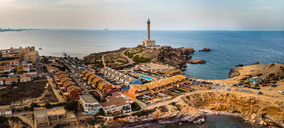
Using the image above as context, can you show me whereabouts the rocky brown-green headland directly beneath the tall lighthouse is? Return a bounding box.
[83,46,195,69]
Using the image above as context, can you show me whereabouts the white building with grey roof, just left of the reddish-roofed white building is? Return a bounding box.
[79,95,102,115]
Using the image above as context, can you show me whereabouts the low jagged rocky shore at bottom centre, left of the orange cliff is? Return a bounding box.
[108,100,205,127]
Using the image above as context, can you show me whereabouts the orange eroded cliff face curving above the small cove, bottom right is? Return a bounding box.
[186,92,284,127]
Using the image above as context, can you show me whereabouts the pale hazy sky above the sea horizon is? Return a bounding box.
[0,0,284,30]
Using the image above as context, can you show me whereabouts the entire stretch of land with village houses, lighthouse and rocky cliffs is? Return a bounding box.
[0,20,284,128]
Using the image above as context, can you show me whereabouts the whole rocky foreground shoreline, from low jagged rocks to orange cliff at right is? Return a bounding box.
[108,92,284,127]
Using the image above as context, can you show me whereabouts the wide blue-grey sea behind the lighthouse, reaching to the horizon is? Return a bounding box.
[0,30,284,80]
